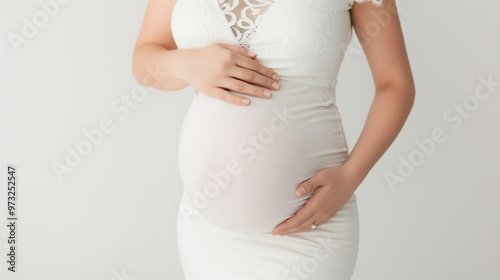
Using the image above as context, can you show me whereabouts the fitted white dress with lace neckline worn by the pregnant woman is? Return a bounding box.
[171,0,382,280]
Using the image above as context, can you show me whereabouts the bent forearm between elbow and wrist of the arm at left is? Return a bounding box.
[132,44,189,91]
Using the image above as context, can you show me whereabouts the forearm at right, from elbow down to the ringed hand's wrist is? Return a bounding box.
[343,86,415,183]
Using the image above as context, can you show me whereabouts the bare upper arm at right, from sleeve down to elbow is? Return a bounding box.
[351,0,414,90]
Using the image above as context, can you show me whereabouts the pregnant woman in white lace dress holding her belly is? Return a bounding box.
[133,0,415,280]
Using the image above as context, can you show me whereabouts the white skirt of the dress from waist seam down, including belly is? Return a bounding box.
[178,79,358,280]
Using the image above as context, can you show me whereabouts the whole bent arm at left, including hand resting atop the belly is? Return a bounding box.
[132,0,279,106]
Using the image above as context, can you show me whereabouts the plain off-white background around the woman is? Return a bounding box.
[0,0,500,280]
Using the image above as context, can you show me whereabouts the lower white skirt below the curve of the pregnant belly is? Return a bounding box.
[177,189,359,280]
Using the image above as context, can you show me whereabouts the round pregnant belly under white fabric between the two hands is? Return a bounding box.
[179,79,348,233]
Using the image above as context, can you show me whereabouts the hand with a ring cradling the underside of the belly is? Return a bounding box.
[272,165,362,235]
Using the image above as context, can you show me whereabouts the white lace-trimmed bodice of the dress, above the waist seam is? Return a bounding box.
[171,0,382,88]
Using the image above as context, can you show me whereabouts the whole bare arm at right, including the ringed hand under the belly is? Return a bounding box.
[273,0,415,235]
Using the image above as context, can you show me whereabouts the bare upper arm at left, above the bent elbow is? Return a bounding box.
[134,0,177,50]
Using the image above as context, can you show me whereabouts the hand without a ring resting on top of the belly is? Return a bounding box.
[179,43,279,105]
